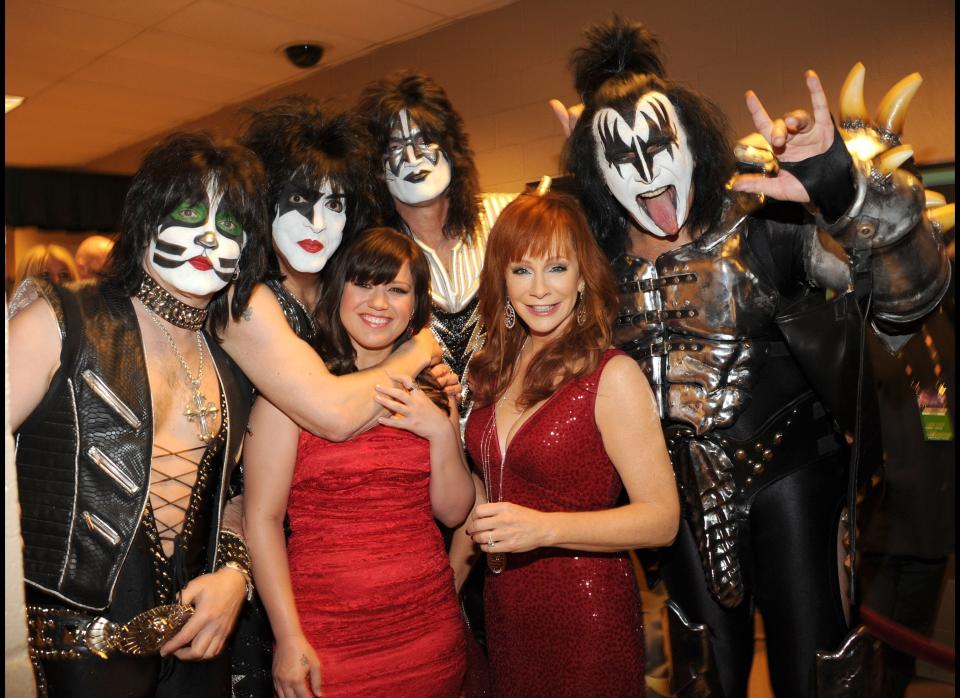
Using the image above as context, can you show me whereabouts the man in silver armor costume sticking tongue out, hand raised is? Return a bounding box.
[559,18,950,698]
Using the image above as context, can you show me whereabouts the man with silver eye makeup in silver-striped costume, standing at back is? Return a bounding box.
[356,72,513,418]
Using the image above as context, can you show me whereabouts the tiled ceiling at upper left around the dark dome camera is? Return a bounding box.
[4,0,512,168]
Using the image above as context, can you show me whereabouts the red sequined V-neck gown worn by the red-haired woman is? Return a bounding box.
[465,350,644,698]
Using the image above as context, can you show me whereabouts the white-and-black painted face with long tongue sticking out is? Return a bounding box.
[593,92,694,237]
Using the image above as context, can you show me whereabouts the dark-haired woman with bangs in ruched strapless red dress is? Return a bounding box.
[244,228,474,698]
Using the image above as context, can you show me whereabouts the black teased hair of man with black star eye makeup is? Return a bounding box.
[241,95,374,274]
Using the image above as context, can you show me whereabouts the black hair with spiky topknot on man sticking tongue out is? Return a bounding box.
[563,16,734,258]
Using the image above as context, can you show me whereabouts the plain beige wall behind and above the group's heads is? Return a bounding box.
[90,0,954,191]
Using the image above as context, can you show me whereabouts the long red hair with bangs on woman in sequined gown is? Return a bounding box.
[469,193,619,407]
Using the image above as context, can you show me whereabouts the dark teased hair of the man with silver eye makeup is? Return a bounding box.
[357,71,480,240]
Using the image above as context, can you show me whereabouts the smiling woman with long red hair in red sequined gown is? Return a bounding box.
[451,193,679,698]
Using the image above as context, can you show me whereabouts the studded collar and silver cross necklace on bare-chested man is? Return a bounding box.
[137,274,219,443]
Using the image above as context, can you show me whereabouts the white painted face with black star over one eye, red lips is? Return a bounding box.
[272,175,347,274]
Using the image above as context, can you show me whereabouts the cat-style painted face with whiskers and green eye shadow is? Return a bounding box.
[147,182,245,296]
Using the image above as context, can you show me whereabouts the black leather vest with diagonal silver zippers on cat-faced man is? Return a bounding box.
[16,282,250,610]
